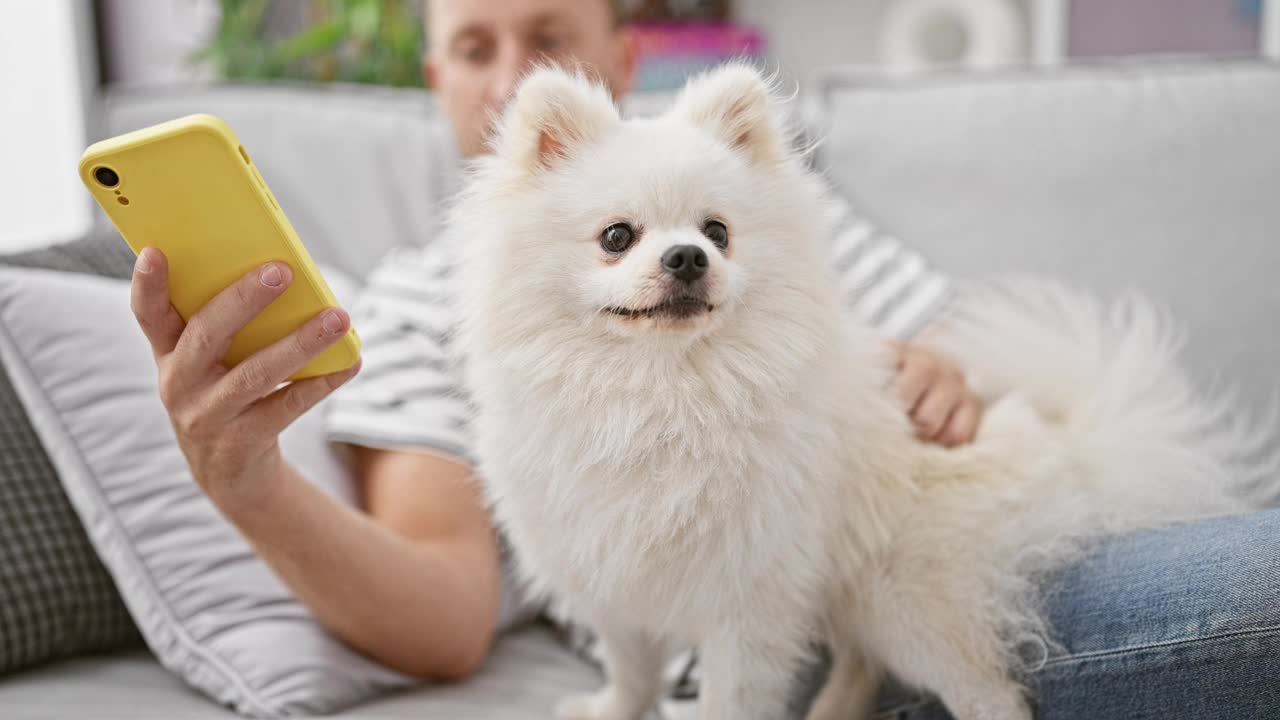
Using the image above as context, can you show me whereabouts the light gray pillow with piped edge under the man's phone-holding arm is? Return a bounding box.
[0,256,424,717]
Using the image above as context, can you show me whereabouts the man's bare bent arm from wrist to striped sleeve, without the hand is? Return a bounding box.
[223,447,500,680]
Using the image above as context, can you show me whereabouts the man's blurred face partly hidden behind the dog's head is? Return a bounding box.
[422,0,634,156]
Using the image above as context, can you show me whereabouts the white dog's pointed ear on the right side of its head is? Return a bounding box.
[673,63,783,164]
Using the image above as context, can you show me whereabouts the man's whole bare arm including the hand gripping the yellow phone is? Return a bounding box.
[131,249,499,679]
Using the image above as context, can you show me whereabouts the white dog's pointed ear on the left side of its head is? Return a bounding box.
[494,67,618,173]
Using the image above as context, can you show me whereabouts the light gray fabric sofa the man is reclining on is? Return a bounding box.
[0,59,1280,720]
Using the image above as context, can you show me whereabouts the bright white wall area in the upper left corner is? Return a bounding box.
[0,0,92,252]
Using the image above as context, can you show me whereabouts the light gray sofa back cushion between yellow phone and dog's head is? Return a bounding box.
[99,83,458,278]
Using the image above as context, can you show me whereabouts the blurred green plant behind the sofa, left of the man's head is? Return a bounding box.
[193,0,422,87]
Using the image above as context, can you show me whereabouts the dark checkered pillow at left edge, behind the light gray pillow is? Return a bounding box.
[0,233,142,675]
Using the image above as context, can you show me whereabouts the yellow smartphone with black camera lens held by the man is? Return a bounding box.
[79,114,360,379]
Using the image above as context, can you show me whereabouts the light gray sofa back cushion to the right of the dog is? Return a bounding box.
[815,60,1280,417]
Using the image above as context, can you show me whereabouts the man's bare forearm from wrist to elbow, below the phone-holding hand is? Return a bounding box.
[223,462,500,680]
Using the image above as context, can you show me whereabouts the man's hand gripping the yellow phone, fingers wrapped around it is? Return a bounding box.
[131,247,360,510]
